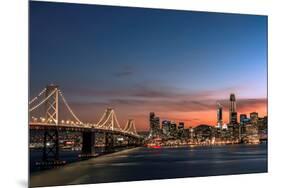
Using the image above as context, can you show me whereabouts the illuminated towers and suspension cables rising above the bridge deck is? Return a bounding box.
[29,85,138,136]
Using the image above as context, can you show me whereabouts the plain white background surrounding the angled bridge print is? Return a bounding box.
[0,0,281,188]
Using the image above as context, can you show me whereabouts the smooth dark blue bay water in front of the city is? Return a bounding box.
[30,144,267,186]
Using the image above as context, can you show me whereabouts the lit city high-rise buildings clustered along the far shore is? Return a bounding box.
[148,94,267,144]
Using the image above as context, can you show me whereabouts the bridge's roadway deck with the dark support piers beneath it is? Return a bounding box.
[29,122,142,164]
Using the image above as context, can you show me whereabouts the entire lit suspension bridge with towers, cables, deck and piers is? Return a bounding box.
[29,84,142,165]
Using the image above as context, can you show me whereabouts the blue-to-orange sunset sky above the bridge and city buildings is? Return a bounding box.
[30,2,267,130]
